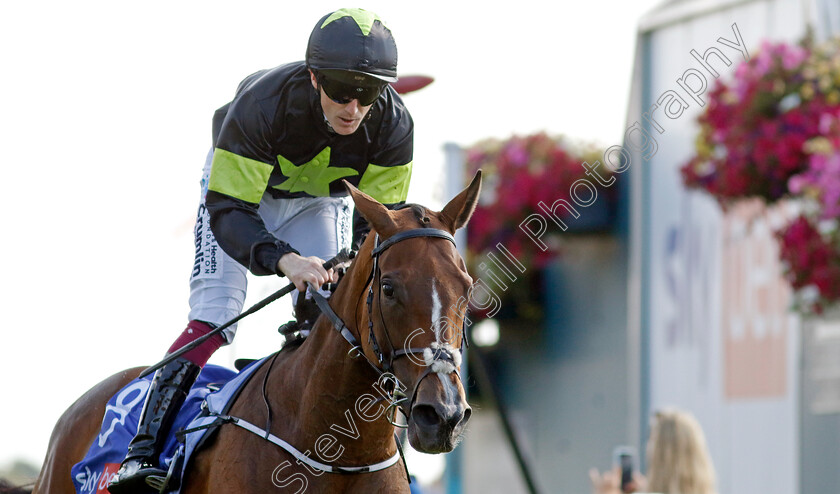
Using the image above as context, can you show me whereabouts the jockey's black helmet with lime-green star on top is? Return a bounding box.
[306,9,397,86]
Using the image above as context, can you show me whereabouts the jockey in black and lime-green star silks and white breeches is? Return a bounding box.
[108,9,414,494]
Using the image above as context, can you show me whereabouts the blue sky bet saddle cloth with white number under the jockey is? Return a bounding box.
[70,359,265,494]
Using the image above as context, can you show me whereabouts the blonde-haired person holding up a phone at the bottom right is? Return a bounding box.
[589,409,717,494]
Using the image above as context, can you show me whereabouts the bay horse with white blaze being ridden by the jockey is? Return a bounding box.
[34,172,481,494]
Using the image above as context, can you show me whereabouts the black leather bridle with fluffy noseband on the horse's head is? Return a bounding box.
[308,228,468,428]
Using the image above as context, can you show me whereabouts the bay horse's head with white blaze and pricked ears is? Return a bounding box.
[348,172,481,453]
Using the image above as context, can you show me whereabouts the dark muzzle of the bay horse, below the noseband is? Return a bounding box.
[408,373,472,453]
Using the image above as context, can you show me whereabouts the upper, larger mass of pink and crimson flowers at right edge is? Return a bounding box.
[681,35,840,206]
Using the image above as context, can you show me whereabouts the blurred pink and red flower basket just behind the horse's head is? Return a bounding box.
[466,133,617,320]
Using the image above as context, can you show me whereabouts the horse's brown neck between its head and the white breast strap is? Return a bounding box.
[274,249,396,464]
